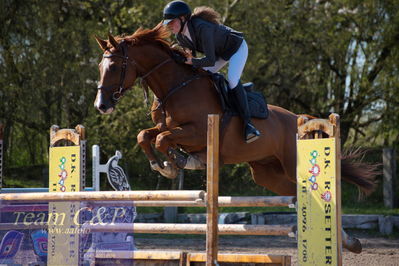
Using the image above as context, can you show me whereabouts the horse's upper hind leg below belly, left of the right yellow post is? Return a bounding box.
[249,159,296,196]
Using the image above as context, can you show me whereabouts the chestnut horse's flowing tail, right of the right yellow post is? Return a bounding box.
[341,149,381,197]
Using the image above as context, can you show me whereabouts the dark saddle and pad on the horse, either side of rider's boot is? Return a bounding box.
[210,73,269,119]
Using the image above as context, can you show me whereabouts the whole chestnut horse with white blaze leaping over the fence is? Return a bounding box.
[94,24,375,253]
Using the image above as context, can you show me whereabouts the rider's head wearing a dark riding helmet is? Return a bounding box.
[163,0,191,34]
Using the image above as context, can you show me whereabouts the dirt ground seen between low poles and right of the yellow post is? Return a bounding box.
[135,234,399,266]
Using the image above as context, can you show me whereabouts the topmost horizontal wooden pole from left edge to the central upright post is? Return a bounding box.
[0,190,205,201]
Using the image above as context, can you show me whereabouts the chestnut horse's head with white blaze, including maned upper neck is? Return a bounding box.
[94,25,170,114]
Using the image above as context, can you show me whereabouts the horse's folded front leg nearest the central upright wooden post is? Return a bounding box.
[155,125,206,178]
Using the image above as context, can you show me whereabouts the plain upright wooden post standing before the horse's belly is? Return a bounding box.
[206,114,220,266]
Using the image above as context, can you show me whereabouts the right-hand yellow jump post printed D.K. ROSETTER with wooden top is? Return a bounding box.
[297,114,342,266]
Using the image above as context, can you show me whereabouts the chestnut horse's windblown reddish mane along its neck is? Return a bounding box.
[108,23,191,57]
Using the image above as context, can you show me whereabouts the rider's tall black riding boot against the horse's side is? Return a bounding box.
[232,82,260,143]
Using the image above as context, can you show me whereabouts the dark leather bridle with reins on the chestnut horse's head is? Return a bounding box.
[97,40,172,102]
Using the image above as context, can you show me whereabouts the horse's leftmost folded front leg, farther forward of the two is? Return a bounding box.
[137,127,164,170]
